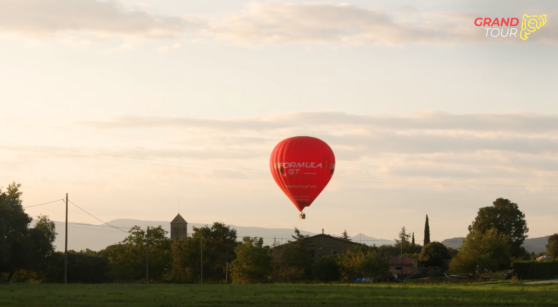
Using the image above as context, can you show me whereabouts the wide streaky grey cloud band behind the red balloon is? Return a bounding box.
[4,112,558,189]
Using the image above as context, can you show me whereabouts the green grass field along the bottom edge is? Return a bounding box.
[0,283,558,307]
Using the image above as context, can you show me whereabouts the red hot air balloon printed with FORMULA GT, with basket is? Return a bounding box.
[269,136,335,219]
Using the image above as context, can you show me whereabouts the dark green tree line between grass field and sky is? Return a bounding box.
[0,183,558,283]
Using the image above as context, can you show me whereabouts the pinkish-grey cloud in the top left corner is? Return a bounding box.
[0,0,197,39]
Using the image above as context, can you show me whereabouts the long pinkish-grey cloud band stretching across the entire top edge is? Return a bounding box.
[0,0,558,46]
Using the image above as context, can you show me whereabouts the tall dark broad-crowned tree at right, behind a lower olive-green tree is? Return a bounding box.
[469,198,529,257]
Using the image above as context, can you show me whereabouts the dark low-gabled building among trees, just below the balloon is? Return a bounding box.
[275,231,360,260]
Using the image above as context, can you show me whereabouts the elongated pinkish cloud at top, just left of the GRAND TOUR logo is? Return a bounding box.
[202,3,482,45]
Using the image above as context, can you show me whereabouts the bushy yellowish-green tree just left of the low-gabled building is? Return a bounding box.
[231,237,273,284]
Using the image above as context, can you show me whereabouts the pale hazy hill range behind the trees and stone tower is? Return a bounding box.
[38,219,393,251]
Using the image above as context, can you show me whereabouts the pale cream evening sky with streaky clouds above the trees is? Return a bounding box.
[0,0,558,242]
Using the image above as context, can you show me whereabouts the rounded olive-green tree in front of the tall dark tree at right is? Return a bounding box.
[449,228,511,274]
